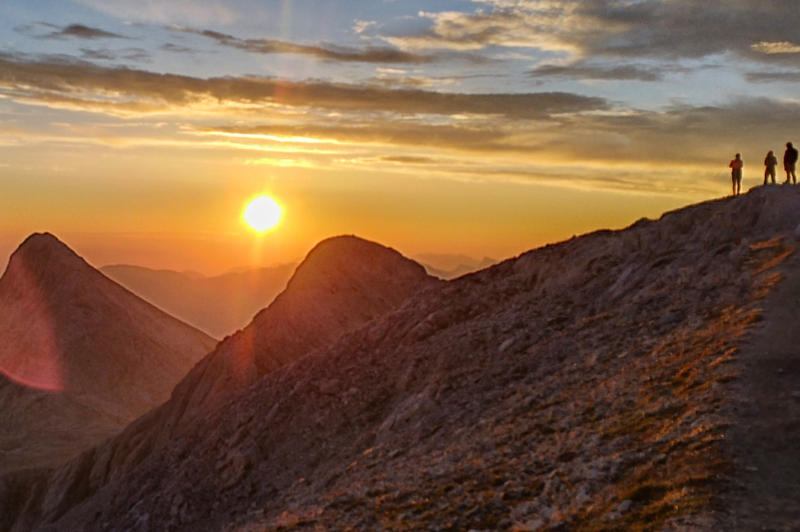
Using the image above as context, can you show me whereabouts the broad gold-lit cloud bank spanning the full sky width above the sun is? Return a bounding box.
[6,50,800,192]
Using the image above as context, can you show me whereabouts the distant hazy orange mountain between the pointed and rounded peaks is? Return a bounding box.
[100,264,297,338]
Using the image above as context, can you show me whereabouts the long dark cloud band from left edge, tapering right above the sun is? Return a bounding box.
[0,54,608,119]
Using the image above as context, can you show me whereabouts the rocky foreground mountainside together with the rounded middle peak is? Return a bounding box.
[0,191,800,532]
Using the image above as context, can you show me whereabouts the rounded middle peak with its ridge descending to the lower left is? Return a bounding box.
[0,236,439,530]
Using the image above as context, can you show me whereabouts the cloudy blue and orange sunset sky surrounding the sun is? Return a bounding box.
[0,0,800,275]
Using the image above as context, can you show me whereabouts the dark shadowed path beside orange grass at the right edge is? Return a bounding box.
[720,237,800,532]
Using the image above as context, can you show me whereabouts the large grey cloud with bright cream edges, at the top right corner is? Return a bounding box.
[384,0,800,67]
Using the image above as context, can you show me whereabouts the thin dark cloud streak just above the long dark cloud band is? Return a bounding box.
[170,26,433,64]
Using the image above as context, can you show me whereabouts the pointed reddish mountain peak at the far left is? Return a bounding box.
[0,233,215,471]
